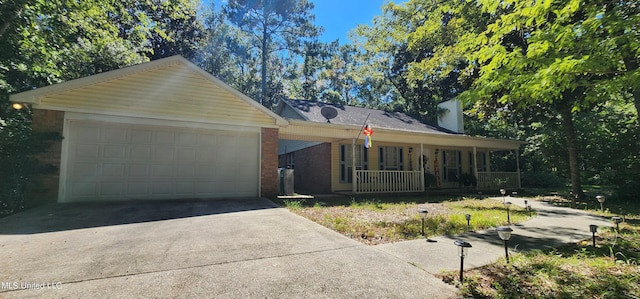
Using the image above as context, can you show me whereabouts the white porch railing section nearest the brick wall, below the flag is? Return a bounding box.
[354,170,424,193]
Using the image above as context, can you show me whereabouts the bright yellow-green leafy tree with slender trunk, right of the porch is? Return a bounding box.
[458,0,636,202]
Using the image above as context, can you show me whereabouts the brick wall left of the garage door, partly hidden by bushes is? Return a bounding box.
[27,109,64,201]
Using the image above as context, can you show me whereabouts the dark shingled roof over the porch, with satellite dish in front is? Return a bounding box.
[276,100,460,135]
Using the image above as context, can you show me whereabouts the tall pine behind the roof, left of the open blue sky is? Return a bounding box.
[224,0,319,107]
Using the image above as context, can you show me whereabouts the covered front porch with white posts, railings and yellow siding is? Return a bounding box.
[279,120,522,194]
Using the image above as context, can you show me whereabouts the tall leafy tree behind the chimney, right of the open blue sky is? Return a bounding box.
[357,0,486,122]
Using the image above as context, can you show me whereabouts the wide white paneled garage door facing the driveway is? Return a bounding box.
[61,121,259,202]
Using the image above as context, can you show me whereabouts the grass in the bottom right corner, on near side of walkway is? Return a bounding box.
[442,214,640,298]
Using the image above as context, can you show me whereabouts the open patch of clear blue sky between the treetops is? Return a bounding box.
[312,0,387,44]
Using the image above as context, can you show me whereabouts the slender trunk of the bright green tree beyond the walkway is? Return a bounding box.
[560,103,583,207]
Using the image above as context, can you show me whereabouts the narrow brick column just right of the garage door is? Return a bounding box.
[260,128,278,197]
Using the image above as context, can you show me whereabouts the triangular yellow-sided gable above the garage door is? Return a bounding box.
[10,55,288,127]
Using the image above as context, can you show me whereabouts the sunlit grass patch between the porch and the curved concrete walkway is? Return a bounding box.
[284,196,529,245]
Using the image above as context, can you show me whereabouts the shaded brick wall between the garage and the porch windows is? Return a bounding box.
[280,143,331,194]
